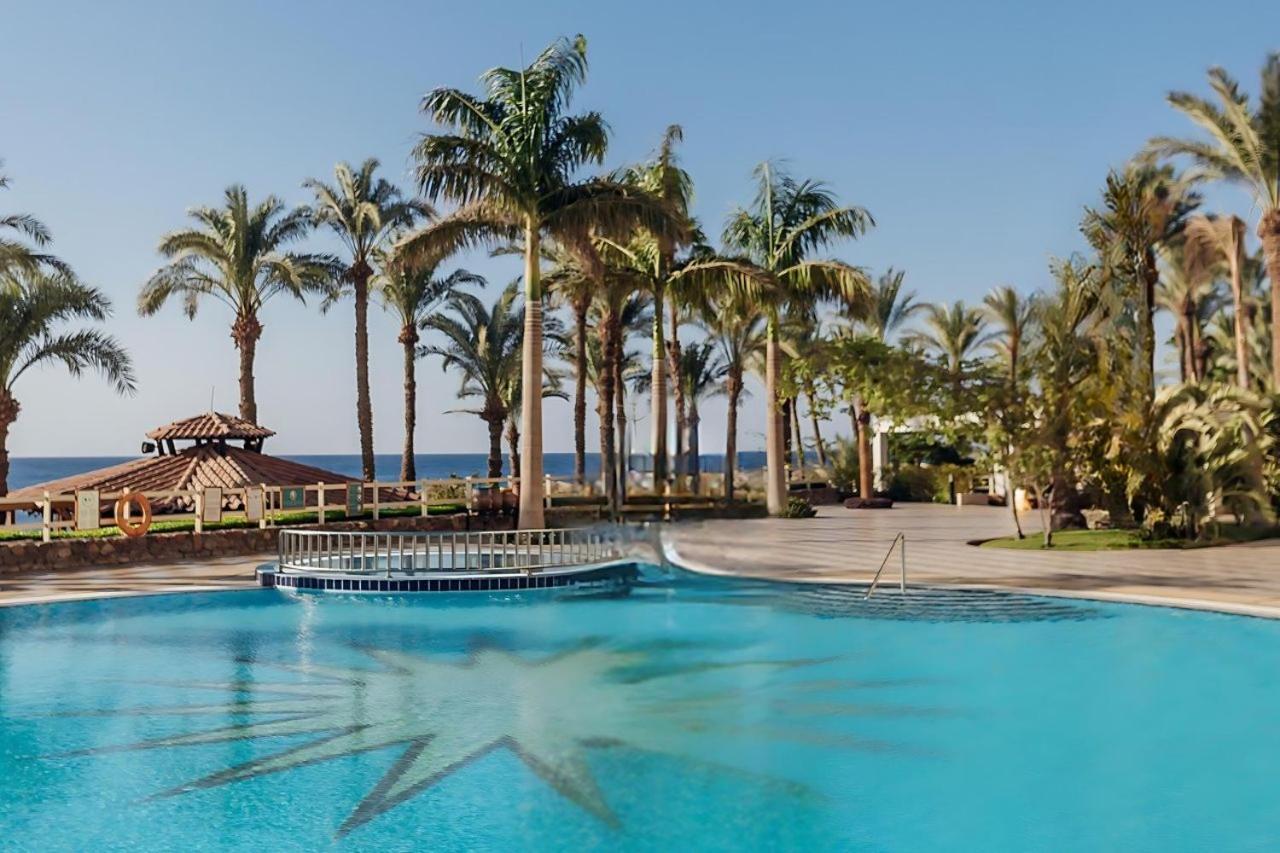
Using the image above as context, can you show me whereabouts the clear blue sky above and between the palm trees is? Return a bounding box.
[0,0,1280,456]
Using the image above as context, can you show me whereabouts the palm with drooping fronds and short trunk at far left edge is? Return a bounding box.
[0,264,134,496]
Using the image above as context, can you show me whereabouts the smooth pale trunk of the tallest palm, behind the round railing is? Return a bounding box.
[520,222,547,529]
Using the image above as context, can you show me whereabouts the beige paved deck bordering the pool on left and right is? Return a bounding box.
[0,505,1280,617]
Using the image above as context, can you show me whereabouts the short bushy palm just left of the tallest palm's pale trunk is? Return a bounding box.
[419,282,526,478]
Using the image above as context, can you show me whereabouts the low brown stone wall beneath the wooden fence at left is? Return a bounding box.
[0,515,512,574]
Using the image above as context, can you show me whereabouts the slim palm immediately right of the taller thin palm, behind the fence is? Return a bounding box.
[372,256,485,480]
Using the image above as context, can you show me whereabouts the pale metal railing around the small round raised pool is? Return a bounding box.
[278,528,622,576]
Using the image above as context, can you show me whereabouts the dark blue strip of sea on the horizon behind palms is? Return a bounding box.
[9,451,764,491]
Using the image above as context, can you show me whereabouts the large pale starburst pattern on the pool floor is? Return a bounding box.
[49,642,931,836]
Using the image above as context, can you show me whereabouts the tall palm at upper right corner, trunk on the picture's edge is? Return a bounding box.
[1149,59,1280,389]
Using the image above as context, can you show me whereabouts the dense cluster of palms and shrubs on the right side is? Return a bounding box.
[788,54,1280,538]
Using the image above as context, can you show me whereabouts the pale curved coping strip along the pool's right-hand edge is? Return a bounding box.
[662,539,1280,620]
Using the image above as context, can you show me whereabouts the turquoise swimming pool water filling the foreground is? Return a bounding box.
[0,575,1280,850]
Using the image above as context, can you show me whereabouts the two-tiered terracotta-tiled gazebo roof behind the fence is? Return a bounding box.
[9,412,360,512]
